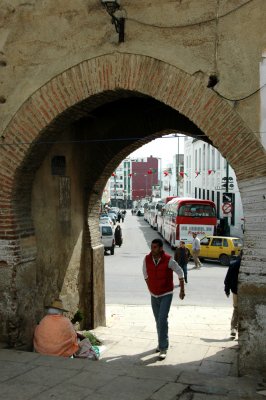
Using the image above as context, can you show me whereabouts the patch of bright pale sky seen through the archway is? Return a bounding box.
[130,135,184,168]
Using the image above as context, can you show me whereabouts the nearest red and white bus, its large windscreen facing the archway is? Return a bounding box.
[162,197,217,247]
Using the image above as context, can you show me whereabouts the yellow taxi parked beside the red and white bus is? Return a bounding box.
[186,236,243,265]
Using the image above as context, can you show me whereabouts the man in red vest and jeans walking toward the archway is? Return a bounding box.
[143,239,185,360]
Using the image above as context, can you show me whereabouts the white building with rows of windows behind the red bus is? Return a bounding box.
[184,137,244,237]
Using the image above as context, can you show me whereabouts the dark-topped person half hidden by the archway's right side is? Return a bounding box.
[224,250,242,337]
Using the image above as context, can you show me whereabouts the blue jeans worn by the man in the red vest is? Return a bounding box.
[151,293,173,350]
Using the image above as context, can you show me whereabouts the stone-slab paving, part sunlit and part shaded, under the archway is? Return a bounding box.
[0,305,266,400]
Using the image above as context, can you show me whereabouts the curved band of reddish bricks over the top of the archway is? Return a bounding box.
[1,53,265,184]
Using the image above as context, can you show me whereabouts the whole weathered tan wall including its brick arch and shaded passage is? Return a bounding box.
[0,0,266,373]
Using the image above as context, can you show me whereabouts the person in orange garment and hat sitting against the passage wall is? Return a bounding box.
[33,300,79,357]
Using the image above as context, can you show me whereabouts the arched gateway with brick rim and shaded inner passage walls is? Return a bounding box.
[0,53,266,372]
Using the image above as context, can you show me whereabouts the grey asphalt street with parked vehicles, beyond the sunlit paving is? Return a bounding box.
[105,211,232,307]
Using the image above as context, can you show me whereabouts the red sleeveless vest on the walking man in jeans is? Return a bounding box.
[145,251,174,296]
